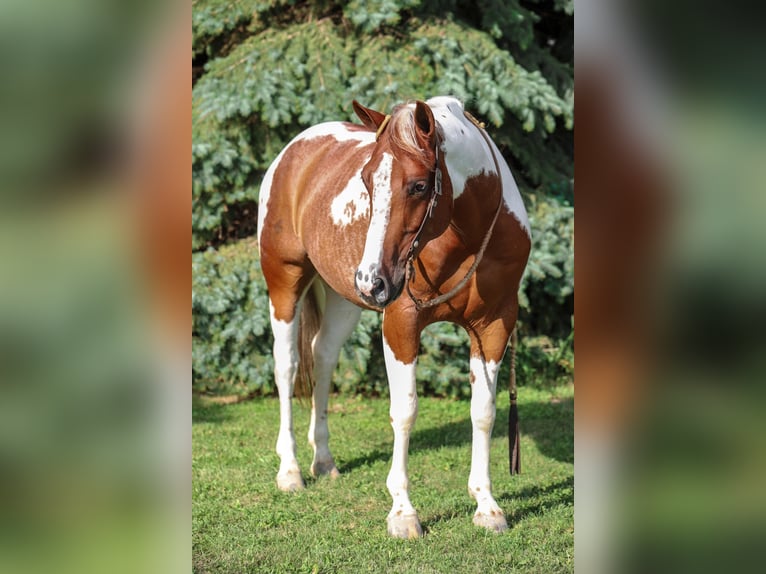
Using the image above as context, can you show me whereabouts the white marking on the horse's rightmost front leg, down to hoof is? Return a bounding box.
[468,357,508,532]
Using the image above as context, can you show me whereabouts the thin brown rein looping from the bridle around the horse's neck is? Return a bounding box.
[404,112,503,311]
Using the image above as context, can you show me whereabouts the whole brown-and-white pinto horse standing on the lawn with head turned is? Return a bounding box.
[257,96,531,538]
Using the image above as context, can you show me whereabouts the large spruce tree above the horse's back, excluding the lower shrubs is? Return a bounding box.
[192,0,573,249]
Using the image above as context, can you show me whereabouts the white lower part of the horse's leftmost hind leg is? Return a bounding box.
[269,300,303,491]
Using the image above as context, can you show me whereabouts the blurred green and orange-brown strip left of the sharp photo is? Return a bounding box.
[0,0,191,573]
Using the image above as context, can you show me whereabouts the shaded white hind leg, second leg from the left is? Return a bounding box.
[308,279,362,478]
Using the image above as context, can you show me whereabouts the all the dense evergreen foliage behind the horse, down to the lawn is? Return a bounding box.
[192,0,574,396]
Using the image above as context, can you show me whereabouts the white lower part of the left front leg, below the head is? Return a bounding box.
[383,337,423,538]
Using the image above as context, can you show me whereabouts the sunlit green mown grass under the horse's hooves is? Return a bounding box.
[192,386,574,574]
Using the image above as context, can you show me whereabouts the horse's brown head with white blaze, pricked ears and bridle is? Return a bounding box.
[354,101,452,308]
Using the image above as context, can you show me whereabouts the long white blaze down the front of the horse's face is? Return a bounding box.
[357,153,393,293]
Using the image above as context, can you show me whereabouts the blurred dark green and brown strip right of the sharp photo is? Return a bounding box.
[575,0,766,572]
